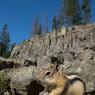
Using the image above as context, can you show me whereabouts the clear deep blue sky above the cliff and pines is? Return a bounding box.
[0,0,95,44]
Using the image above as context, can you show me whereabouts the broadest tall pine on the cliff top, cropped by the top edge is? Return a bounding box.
[60,0,81,25]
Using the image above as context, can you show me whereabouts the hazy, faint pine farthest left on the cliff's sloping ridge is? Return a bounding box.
[32,17,42,36]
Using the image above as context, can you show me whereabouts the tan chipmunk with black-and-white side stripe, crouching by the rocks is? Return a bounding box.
[39,64,86,95]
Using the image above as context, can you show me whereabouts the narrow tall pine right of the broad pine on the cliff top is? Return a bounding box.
[82,0,91,24]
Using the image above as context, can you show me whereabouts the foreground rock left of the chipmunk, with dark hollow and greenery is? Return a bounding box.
[0,66,44,95]
